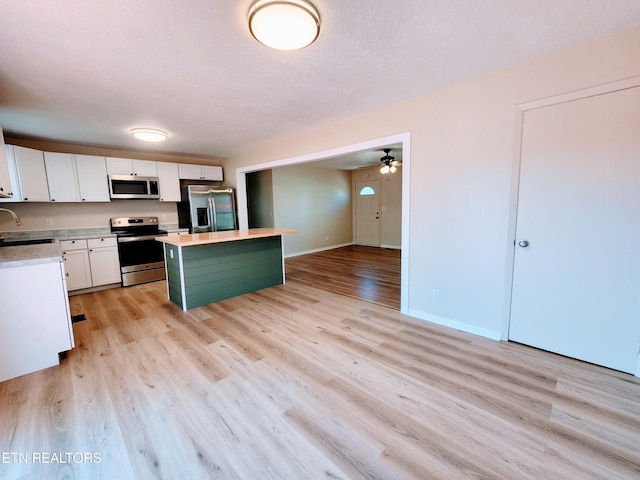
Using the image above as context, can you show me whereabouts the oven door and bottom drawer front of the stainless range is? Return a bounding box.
[118,234,165,287]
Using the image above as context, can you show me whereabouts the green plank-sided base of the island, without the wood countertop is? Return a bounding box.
[165,235,283,310]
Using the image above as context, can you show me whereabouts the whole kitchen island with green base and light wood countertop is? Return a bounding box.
[156,228,298,311]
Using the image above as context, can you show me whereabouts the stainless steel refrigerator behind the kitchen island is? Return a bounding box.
[185,185,237,233]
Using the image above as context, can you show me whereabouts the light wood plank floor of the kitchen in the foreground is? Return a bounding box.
[0,249,640,480]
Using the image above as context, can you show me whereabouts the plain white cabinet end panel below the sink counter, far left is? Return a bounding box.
[0,261,74,382]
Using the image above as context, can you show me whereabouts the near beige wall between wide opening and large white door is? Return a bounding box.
[225,27,640,338]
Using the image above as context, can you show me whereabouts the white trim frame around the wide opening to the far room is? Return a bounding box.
[236,132,411,315]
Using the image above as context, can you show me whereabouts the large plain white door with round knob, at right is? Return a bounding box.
[509,88,640,374]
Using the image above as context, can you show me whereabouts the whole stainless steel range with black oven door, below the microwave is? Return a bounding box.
[111,217,167,287]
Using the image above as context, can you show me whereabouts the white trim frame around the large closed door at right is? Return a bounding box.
[500,76,640,377]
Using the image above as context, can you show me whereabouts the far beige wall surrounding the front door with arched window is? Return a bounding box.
[351,167,402,248]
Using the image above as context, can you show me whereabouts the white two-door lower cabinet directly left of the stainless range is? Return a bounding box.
[60,237,121,292]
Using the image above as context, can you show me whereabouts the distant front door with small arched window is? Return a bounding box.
[356,180,380,247]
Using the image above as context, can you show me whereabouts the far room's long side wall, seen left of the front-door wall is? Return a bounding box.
[272,165,353,255]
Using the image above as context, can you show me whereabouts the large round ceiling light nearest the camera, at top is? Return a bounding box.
[249,0,320,50]
